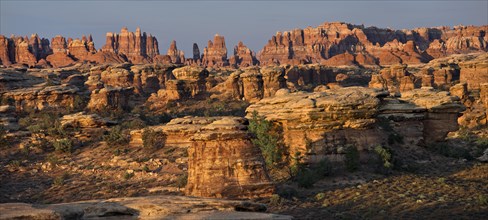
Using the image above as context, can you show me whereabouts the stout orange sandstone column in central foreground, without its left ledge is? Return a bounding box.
[186,117,274,198]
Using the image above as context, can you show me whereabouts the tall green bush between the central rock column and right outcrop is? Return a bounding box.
[249,111,282,167]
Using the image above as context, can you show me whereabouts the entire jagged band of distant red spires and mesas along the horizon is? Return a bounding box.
[0,22,488,68]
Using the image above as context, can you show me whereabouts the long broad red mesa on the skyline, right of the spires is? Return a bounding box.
[258,22,488,66]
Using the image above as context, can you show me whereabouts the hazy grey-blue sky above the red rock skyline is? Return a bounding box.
[0,0,488,57]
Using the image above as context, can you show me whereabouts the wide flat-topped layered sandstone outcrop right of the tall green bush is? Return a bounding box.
[246,87,464,161]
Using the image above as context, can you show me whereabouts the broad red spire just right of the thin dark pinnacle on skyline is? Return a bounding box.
[202,34,229,67]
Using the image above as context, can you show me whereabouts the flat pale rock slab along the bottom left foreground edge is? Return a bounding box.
[0,196,293,220]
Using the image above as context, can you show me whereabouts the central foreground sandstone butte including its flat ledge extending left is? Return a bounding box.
[130,116,274,198]
